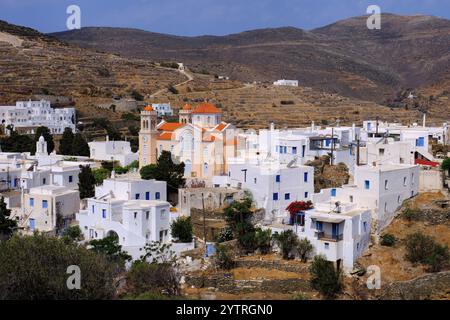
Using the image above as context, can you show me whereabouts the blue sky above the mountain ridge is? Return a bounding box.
[0,0,450,36]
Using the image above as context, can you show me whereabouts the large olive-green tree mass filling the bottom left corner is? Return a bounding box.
[0,233,115,300]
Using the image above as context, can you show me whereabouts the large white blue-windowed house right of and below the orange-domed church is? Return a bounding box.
[213,159,314,222]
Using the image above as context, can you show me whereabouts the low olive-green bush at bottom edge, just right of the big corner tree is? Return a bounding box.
[127,261,180,296]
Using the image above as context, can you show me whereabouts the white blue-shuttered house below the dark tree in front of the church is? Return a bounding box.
[76,178,171,259]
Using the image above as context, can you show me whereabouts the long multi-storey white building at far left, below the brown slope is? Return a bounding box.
[0,100,76,134]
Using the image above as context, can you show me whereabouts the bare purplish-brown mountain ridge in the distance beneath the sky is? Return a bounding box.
[52,14,450,102]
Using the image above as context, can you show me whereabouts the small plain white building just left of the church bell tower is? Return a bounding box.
[88,140,139,166]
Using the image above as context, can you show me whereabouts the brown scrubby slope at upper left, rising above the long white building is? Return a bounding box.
[0,21,185,115]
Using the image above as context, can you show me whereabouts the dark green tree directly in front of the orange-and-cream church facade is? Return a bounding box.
[140,151,186,194]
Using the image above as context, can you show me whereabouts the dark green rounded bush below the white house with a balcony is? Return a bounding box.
[309,256,342,299]
